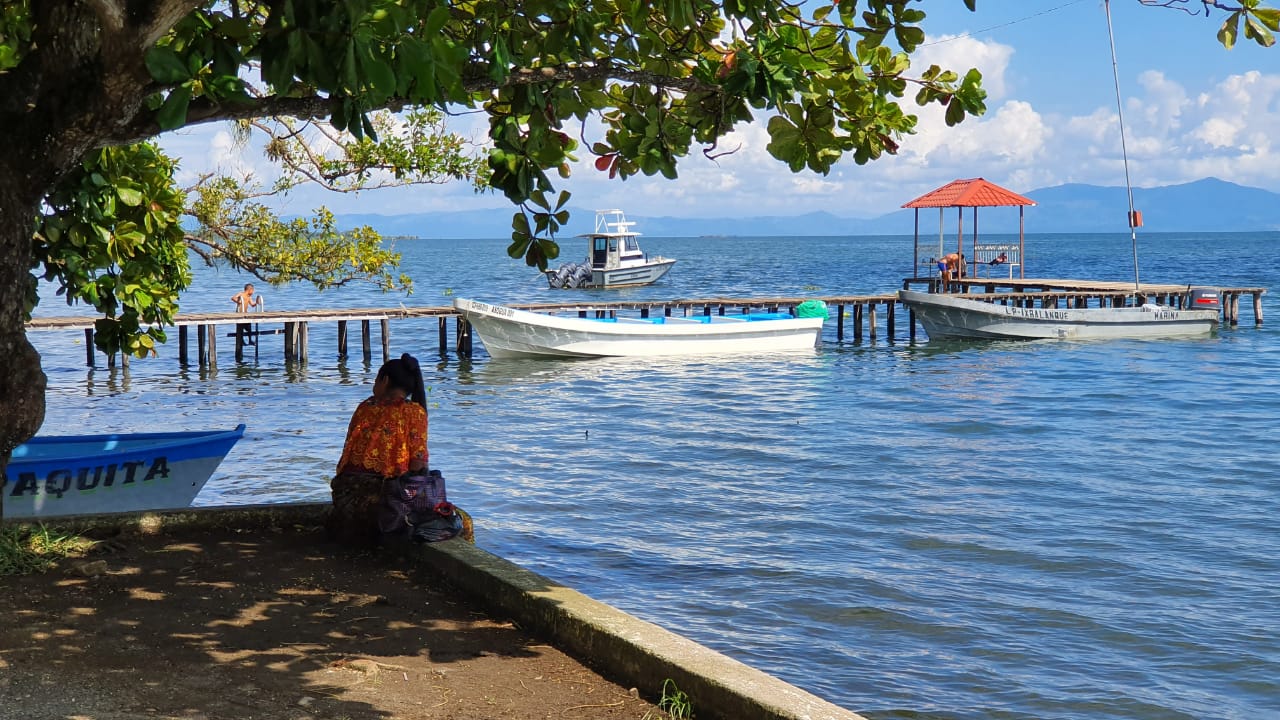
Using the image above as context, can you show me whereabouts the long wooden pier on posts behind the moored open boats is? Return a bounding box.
[27,278,1266,368]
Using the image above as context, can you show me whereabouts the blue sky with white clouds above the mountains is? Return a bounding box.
[161,0,1280,218]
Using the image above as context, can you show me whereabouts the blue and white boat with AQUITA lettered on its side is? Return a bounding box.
[0,424,244,519]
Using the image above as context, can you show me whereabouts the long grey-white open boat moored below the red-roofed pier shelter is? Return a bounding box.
[897,290,1219,340]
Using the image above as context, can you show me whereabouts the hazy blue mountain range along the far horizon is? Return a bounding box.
[338,178,1280,238]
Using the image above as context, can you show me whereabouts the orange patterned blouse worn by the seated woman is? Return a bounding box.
[338,397,428,478]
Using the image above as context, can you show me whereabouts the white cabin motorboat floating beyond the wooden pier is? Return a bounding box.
[547,210,676,288]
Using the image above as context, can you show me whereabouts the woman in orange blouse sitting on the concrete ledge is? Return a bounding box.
[328,352,429,544]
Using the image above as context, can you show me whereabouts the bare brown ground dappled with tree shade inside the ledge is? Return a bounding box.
[0,515,666,720]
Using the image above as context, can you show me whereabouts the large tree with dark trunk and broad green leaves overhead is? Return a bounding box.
[0,0,1280,515]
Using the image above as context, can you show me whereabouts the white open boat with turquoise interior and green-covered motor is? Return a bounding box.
[453,297,827,357]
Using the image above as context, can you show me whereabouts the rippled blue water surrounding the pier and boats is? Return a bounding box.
[24,228,1280,720]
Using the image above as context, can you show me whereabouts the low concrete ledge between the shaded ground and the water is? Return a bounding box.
[6,502,865,720]
